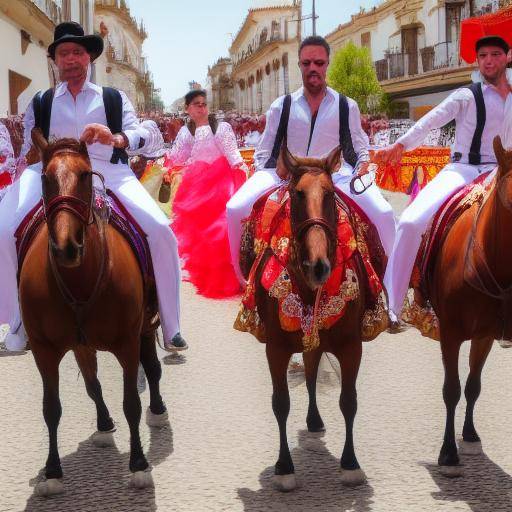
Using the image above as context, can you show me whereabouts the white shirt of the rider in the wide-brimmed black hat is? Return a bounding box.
[21,81,146,161]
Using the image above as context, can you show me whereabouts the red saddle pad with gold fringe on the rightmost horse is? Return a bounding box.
[402,171,495,340]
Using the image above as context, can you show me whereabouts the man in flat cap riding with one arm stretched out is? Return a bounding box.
[376,36,512,332]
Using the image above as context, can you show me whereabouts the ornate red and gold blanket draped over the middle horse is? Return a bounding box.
[235,186,387,350]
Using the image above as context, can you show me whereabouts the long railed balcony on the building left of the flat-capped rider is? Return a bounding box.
[374,42,463,82]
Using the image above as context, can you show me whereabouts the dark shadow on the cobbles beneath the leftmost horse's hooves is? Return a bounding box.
[25,425,173,512]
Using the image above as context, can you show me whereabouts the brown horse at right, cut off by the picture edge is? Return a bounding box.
[429,137,512,476]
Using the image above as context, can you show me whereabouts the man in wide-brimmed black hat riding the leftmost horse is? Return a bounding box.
[0,22,186,350]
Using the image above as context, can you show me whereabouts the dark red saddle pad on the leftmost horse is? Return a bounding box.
[14,190,154,282]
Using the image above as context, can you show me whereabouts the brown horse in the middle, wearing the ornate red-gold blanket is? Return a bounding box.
[255,147,365,491]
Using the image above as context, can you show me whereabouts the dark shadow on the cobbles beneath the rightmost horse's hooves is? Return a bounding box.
[423,453,512,512]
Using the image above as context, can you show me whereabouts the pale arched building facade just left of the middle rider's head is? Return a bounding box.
[229,0,302,114]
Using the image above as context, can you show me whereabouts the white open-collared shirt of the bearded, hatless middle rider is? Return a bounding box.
[254,87,370,171]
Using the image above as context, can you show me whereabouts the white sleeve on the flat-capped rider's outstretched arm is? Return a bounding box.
[397,89,466,151]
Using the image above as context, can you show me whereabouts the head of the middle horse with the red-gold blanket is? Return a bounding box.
[280,145,340,290]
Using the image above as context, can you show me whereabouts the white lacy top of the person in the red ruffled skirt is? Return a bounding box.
[169,122,244,167]
